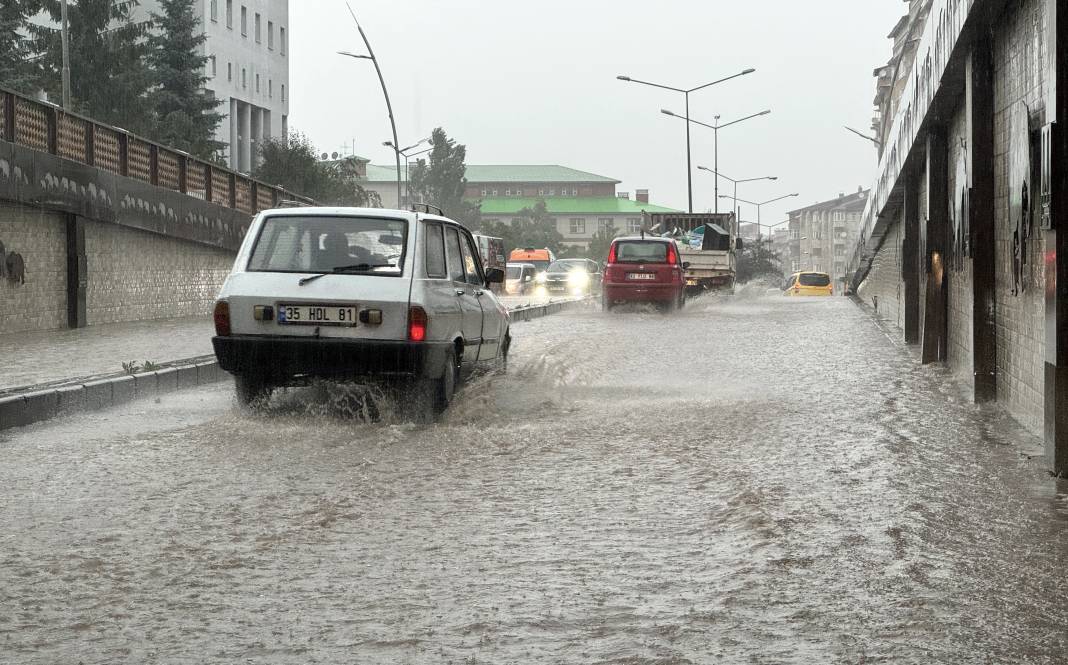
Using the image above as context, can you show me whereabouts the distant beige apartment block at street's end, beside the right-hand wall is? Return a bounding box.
[783,188,869,294]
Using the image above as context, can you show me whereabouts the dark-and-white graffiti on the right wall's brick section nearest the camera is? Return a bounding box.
[1008,104,1034,296]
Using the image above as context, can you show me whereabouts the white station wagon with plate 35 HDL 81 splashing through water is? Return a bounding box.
[213,207,512,412]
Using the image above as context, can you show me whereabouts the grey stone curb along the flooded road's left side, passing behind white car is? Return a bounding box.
[0,298,591,431]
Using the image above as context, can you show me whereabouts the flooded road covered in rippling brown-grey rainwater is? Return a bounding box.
[0,298,1068,665]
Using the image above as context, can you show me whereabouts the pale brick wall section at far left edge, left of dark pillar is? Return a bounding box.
[0,202,67,334]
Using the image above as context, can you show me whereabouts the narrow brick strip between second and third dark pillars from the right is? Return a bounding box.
[946,99,974,385]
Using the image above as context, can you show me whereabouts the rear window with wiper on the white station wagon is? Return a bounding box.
[248,216,408,276]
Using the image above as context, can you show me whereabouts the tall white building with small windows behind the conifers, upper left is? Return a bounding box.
[136,0,289,173]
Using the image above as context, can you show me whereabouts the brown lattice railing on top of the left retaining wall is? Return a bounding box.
[0,83,314,215]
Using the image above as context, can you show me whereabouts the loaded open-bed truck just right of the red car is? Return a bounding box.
[642,212,741,296]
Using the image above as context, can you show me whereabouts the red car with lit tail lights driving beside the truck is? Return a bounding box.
[601,237,688,311]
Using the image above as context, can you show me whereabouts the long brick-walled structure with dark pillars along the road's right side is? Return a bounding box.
[851,0,1068,474]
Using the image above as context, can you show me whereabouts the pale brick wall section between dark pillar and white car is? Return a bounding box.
[84,222,234,326]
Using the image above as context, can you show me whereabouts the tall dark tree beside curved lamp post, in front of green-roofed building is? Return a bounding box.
[409,127,482,228]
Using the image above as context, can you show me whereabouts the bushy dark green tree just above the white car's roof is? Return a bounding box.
[255,131,381,207]
